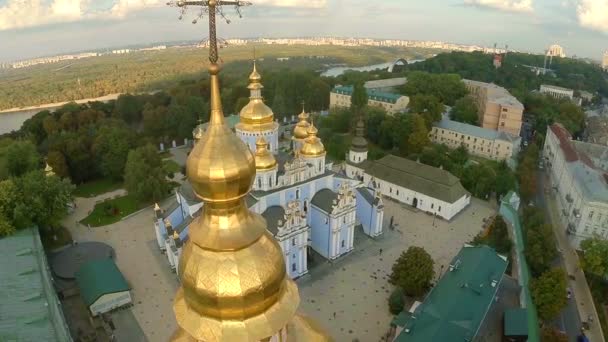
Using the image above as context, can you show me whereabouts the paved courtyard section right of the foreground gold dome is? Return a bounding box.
[297,199,496,342]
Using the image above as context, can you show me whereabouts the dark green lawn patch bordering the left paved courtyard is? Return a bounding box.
[80,195,146,227]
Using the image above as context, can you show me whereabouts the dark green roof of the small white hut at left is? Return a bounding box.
[76,258,131,306]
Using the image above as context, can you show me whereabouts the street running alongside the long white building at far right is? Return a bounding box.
[536,171,602,342]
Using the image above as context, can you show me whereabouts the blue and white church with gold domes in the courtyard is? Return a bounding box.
[154,64,384,278]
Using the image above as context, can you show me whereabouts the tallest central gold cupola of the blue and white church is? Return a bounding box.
[237,62,275,132]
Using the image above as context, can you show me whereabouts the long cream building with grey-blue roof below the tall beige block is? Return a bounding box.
[430,117,521,160]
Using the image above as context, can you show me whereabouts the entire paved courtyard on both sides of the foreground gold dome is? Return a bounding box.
[64,187,495,342]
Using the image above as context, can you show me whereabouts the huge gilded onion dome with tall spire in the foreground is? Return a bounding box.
[172,64,302,342]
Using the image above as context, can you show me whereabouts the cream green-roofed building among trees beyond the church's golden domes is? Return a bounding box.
[329,86,410,114]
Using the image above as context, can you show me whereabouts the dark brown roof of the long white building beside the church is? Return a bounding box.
[360,154,469,203]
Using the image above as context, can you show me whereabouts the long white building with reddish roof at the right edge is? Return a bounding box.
[543,124,608,248]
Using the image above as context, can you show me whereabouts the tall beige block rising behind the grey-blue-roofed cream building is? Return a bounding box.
[463,80,524,136]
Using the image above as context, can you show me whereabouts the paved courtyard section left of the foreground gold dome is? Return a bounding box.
[63,194,178,342]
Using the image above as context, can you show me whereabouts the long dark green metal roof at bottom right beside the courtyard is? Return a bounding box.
[396,245,507,342]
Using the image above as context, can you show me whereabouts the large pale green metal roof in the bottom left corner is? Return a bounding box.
[0,228,72,342]
